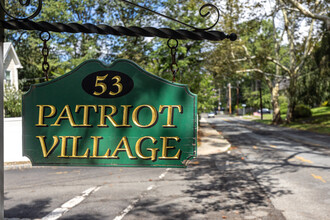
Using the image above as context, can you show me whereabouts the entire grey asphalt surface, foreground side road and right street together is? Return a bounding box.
[5,117,330,220]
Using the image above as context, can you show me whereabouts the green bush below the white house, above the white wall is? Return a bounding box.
[3,84,22,117]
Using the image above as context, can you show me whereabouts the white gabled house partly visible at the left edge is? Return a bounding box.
[3,42,23,89]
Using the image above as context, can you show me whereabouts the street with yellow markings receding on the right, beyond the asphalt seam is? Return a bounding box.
[209,116,330,220]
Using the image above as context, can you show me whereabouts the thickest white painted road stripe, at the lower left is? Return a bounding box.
[42,186,101,220]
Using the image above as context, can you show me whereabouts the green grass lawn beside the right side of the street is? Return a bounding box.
[254,106,330,135]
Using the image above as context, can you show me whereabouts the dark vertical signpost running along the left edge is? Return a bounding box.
[0,0,5,219]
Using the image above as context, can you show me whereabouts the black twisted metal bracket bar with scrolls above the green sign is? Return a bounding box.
[0,0,237,41]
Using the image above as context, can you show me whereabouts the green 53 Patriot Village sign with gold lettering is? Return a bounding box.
[23,60,197,167]
